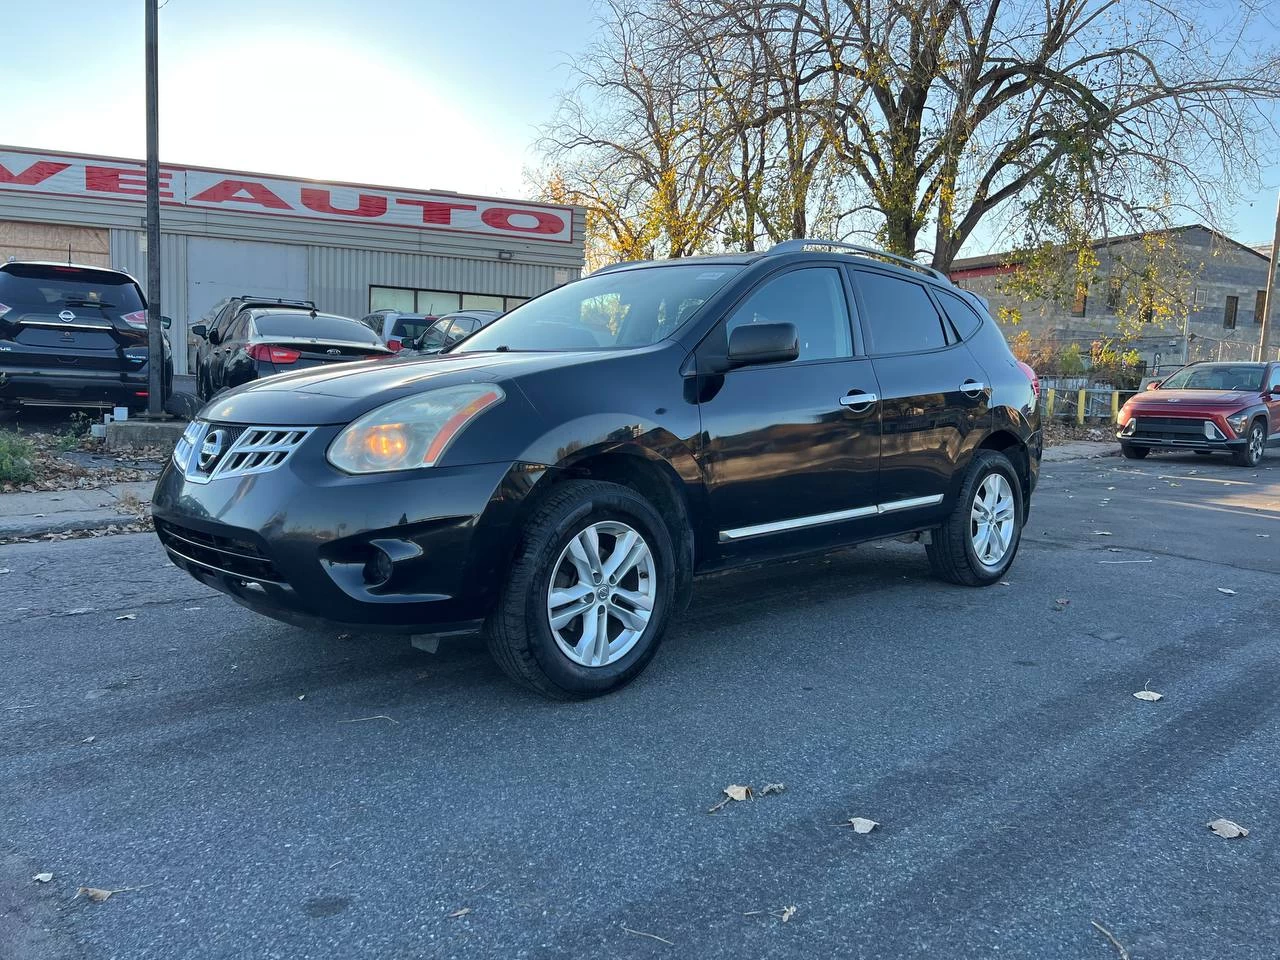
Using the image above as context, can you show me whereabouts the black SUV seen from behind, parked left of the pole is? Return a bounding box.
[0,260,173,411]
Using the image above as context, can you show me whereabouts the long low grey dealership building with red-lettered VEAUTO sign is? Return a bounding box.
[0,146,584,372]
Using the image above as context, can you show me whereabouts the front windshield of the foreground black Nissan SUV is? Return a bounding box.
[451,264,742,353]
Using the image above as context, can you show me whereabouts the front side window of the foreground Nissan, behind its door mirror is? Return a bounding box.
[727,266,854,360]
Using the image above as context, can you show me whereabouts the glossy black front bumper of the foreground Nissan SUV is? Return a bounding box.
[151,428,544,634]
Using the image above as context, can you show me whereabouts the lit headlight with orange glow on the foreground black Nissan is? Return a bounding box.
[326,384,507,474]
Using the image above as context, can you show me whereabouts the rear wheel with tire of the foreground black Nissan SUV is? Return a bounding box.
[925,451,1027,586]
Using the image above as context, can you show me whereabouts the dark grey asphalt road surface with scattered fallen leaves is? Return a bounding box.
[0,451,1280,960]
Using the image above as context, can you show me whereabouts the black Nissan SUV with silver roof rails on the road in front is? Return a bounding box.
[152,241,1041,698]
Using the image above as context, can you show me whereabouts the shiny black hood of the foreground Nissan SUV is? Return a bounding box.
[200,351,614,426]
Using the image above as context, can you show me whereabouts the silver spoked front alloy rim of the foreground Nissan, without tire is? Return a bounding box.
[547,520,657,667]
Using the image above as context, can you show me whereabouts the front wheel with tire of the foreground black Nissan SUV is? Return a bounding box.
[485,480,677,700]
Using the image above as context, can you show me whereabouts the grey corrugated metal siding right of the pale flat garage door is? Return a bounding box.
[307,247,581,317]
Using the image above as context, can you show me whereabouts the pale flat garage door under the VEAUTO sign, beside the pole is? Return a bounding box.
[187,237,308,370]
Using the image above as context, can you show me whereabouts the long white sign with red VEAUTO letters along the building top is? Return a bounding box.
[0,147,573,243]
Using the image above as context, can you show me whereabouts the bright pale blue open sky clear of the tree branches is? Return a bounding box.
[0,0,1280,253]
